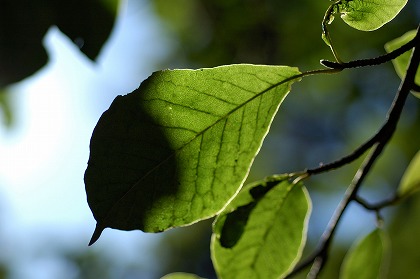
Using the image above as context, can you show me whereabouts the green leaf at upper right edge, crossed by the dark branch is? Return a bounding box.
[385,30,420,98]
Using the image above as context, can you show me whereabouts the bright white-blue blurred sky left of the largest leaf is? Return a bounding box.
[0,1,170,278]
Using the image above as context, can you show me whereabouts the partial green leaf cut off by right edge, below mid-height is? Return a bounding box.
[398,151,420,199]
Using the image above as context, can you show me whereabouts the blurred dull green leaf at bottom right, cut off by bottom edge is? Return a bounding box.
[340,229,389,279]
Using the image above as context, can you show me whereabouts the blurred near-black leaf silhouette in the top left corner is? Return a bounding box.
[0,0,118,87]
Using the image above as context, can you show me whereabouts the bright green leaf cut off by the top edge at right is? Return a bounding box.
[338,0,408,31]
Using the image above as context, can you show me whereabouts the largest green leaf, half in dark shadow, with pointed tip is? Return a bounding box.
[85,64,300,242]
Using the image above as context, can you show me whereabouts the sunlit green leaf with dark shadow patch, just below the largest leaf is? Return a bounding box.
[211,180,311,279]
